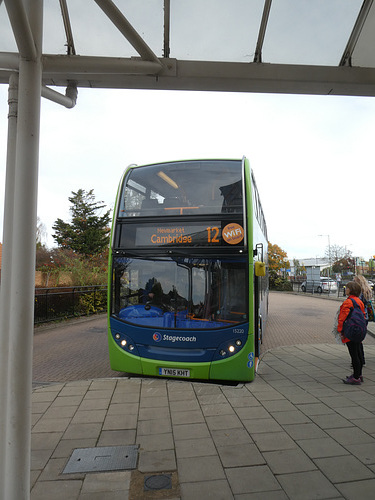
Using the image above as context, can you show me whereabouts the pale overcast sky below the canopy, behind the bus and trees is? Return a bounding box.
[0,85,375,260]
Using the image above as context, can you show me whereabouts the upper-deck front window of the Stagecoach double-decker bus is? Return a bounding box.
[118,160,243,217]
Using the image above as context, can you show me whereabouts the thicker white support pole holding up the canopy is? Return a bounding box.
[3,0,43,500]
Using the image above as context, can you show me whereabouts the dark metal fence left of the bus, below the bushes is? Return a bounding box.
[34,285,107,324]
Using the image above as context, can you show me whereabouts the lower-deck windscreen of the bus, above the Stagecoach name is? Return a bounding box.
[113,257,248,330]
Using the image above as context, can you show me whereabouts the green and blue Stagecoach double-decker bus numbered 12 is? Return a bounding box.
[108,158,268,381]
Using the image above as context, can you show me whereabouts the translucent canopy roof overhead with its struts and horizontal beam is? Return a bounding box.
[0,0,375,95]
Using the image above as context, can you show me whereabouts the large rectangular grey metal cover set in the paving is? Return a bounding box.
[63,445,138,474]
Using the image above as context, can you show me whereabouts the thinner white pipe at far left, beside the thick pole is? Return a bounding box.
[0,74,18,498]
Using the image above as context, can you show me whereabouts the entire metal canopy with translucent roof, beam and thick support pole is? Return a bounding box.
[0,0,375,500]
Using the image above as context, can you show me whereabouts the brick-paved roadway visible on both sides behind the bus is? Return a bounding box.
[33,292,375,386]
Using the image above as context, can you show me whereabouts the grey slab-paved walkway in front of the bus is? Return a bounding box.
[31,296,375,500]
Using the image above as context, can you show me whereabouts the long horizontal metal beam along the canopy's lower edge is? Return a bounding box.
[26,56,375,96]
